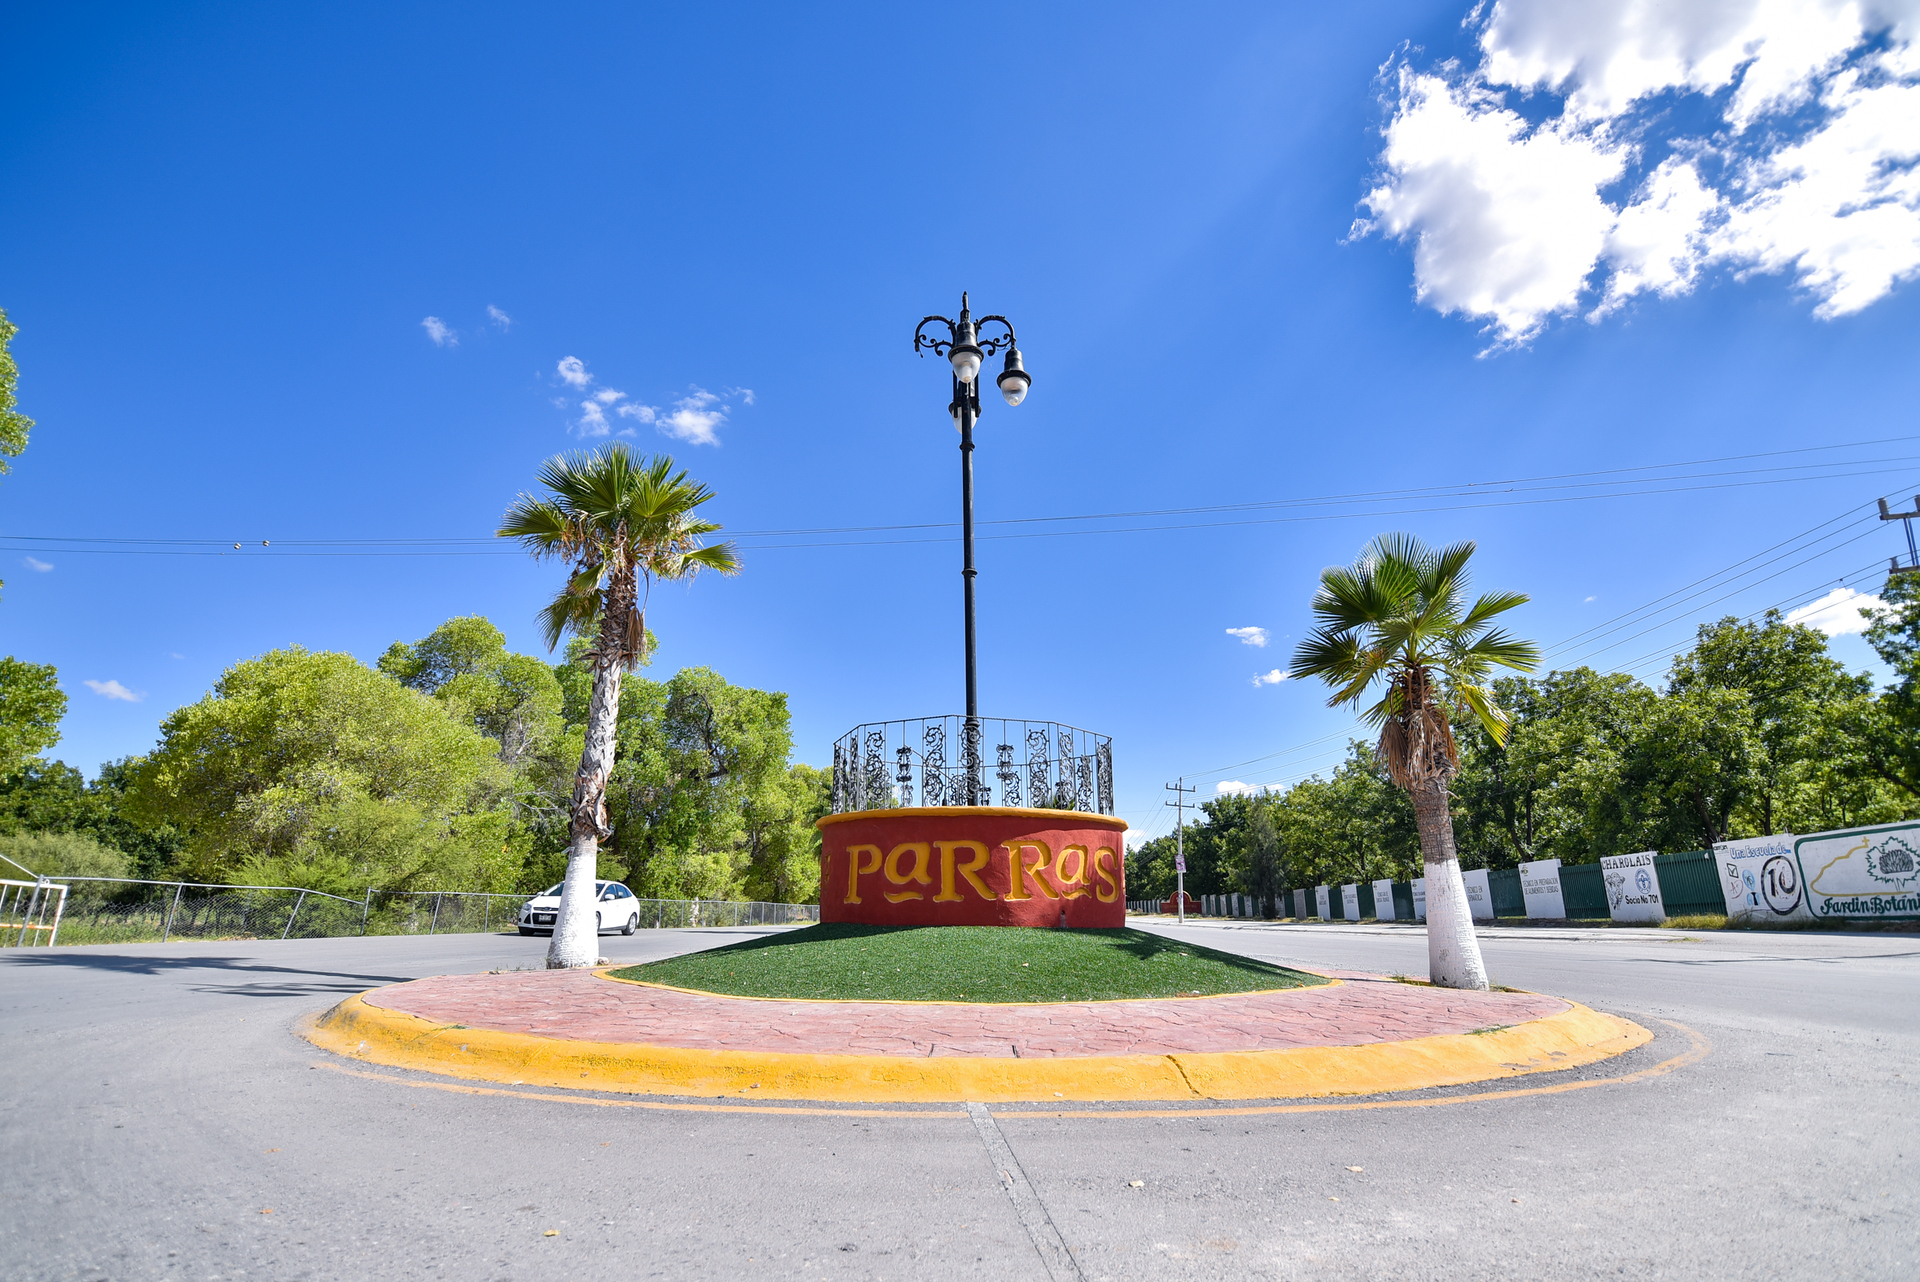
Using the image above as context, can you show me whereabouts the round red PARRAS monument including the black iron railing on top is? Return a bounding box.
[818,718,1127,927]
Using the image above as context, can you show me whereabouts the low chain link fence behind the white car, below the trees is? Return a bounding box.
[28,877,820,944]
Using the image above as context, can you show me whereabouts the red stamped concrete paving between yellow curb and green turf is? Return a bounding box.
[365,971,1569,1059]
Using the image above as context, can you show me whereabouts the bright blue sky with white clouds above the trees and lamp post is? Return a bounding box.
[0,0,1920,852]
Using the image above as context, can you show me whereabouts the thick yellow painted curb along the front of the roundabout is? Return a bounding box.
[303,994,1653,1104]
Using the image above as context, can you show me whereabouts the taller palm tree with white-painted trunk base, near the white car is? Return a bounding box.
[495,443,739,969]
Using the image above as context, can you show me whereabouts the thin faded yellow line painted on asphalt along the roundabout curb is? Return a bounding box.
[311,1019,1713,1121]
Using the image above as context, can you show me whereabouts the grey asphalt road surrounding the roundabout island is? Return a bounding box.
[0,925,1920,1282]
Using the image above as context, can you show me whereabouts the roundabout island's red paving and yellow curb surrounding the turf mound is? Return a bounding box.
[305,927,1653,1104]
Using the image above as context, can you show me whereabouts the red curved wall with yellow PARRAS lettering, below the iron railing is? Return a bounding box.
[818,806,1127,927]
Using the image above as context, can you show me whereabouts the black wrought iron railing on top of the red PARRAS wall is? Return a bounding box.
[833,716,1114,814]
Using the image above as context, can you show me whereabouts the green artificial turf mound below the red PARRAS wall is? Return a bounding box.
[614,923,1327,1002]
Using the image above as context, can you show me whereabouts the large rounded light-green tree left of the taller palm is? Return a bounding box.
[125,647,515,890]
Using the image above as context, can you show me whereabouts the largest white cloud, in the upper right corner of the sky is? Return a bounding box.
[1356,0,1920,345]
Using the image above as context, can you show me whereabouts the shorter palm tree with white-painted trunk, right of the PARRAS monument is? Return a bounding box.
[1292,534,1540,988]
